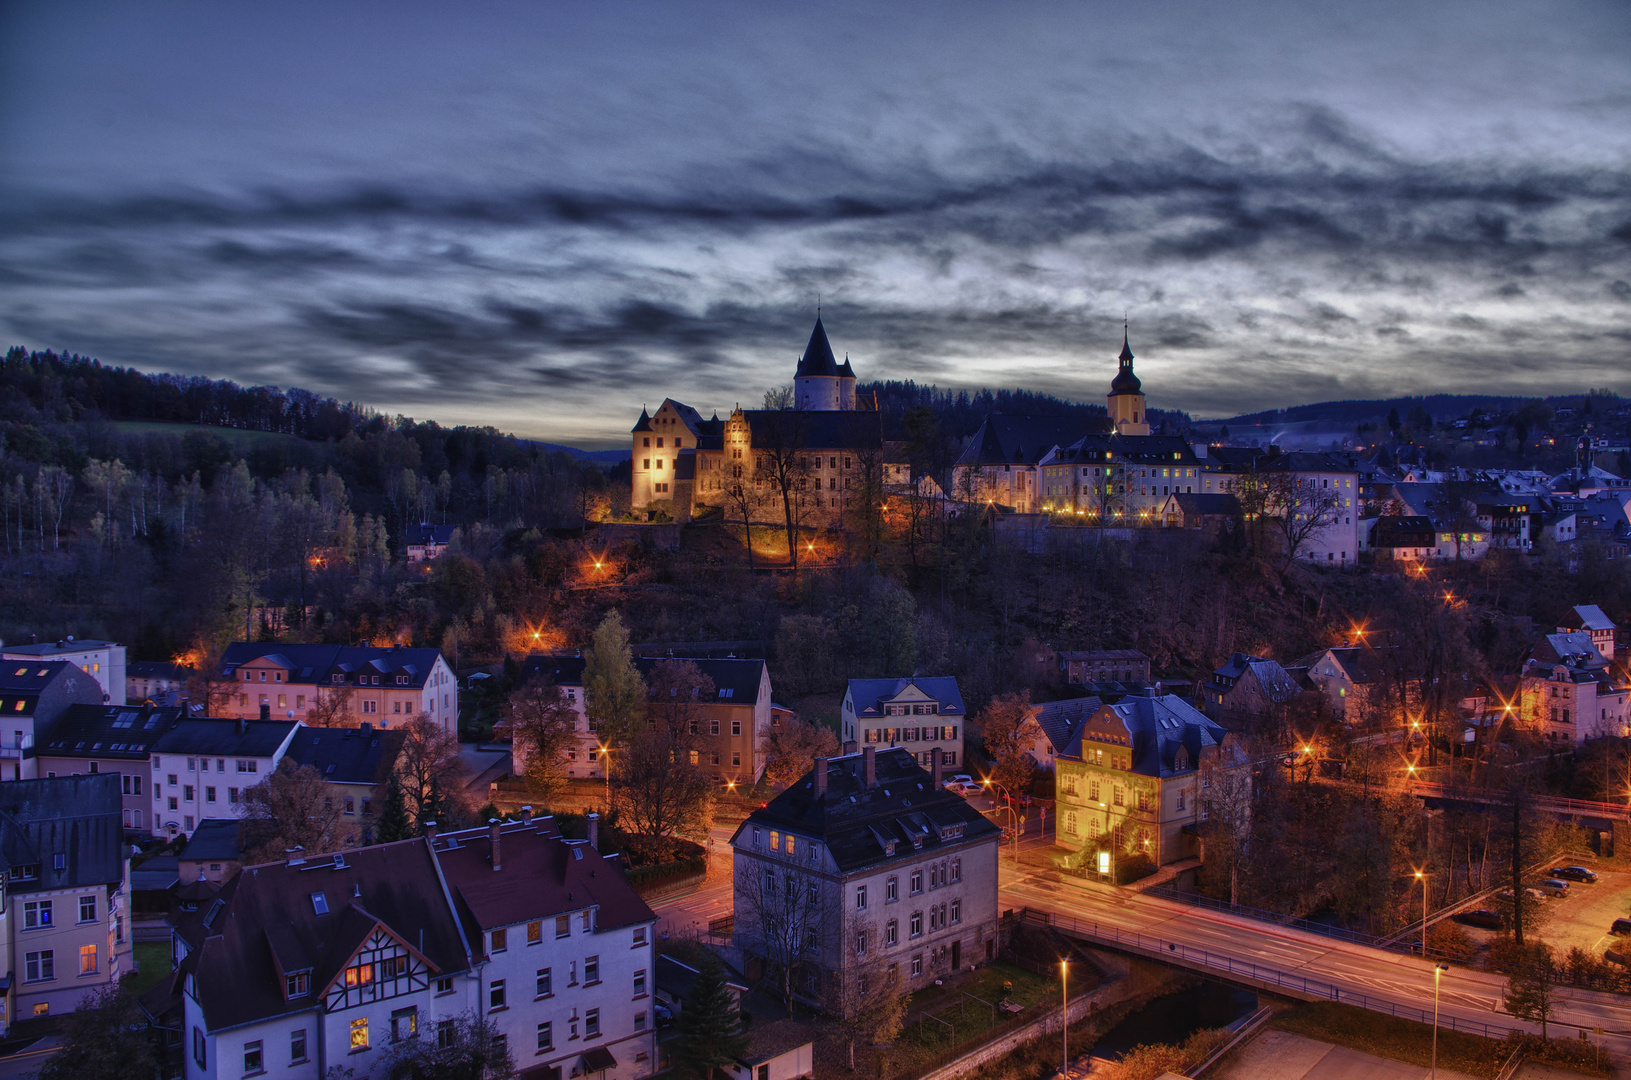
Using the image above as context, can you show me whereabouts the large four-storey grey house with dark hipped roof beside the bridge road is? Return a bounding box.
[731,746,1000,1013]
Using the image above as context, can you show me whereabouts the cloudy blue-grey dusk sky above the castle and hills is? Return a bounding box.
[0,0,1631,447]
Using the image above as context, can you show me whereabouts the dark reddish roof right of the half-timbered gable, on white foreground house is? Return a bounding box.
[435,817,656,930]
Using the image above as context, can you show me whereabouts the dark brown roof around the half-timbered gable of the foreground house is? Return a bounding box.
[192,839,470,1031]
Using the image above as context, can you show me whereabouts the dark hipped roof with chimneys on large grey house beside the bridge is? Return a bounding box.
[731,747,998,873]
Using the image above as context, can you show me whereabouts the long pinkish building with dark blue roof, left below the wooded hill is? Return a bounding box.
[210,641,458,731]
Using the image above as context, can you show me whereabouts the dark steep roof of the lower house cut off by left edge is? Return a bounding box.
[0,773,126,892]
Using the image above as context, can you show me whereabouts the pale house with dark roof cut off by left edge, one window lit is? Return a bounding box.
[0,775,132,1033]
